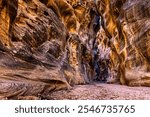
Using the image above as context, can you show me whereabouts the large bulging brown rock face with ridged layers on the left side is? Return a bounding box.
[0,0,74,98]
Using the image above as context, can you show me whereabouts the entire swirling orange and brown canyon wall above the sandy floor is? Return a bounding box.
[0,0,150,99]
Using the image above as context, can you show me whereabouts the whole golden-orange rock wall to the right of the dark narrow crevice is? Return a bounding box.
[97,0,150,86]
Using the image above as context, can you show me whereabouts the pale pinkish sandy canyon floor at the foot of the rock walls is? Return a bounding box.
[48,83,150,100]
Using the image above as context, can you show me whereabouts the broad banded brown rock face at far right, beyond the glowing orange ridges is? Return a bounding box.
[122,0,150,86]
